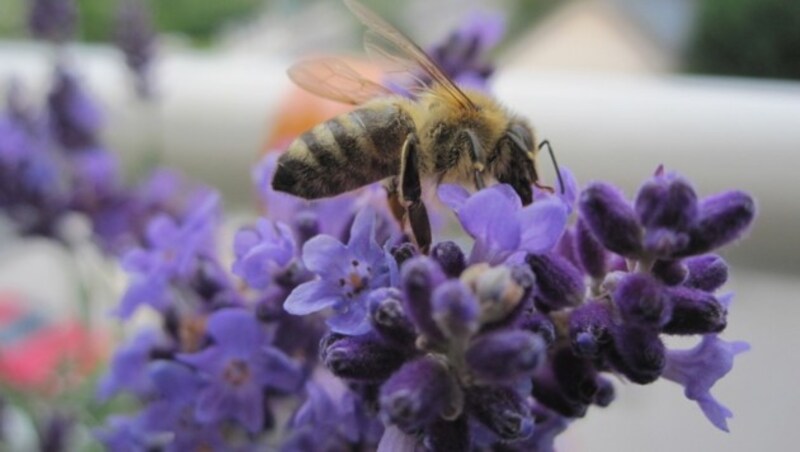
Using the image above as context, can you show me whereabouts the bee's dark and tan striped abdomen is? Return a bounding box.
[272,100,415,199]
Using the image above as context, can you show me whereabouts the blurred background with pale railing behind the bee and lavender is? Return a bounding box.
[0,0,800,452]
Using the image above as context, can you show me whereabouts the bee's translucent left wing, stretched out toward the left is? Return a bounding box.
[289,58,392,105]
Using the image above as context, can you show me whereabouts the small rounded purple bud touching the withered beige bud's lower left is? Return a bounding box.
[433,279,480,339]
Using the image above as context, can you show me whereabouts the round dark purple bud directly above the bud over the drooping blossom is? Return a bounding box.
[613,273,670,326]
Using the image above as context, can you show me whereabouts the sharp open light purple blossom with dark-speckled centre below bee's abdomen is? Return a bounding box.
[284,209,397,334]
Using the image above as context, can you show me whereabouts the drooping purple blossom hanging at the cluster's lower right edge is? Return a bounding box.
[661,334,750,432]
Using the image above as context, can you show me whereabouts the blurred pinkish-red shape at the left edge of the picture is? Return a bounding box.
[0,293,105,391]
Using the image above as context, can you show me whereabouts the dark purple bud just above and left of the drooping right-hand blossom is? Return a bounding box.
[608,327,666,384]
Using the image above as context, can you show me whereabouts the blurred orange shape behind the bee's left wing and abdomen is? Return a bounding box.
[262,57,382,154]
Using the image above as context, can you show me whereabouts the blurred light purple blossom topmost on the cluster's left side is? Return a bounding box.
[116,194,219,318]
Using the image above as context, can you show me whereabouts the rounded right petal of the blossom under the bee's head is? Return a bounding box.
[517,198,569,254]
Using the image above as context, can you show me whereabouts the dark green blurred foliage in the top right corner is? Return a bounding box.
[687,0,800,79]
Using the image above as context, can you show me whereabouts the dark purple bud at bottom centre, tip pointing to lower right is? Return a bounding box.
[466,386,533,441]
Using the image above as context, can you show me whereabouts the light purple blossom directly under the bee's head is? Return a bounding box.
[439,184,568,265]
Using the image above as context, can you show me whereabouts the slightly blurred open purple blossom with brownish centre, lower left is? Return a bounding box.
[178,309,301,432]
